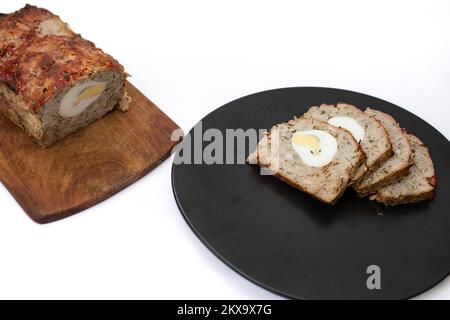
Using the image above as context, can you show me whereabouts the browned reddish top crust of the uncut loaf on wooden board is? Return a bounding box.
[0,5,124,114]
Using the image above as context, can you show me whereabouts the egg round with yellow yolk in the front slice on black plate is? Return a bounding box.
[291,130,338,168]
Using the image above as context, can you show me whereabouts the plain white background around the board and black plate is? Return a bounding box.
[0,0,450,299]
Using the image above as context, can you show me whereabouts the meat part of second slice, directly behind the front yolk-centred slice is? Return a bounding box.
[304,103,392,181]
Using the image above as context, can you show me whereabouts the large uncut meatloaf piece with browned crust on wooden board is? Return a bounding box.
[0,5,129,147]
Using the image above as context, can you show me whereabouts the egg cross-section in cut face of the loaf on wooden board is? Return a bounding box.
[59,81,106,118]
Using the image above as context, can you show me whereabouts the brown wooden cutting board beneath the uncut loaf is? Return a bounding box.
[0,83,181,223]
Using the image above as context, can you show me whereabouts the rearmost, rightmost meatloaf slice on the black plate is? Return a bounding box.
[371,134,437,206]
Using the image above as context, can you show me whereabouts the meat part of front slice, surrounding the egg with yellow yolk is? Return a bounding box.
[248,118,365,205]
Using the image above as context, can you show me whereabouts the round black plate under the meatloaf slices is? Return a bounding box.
[172,88,450,299]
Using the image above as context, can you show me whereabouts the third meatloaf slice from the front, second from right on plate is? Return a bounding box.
[354,108,412,197]
